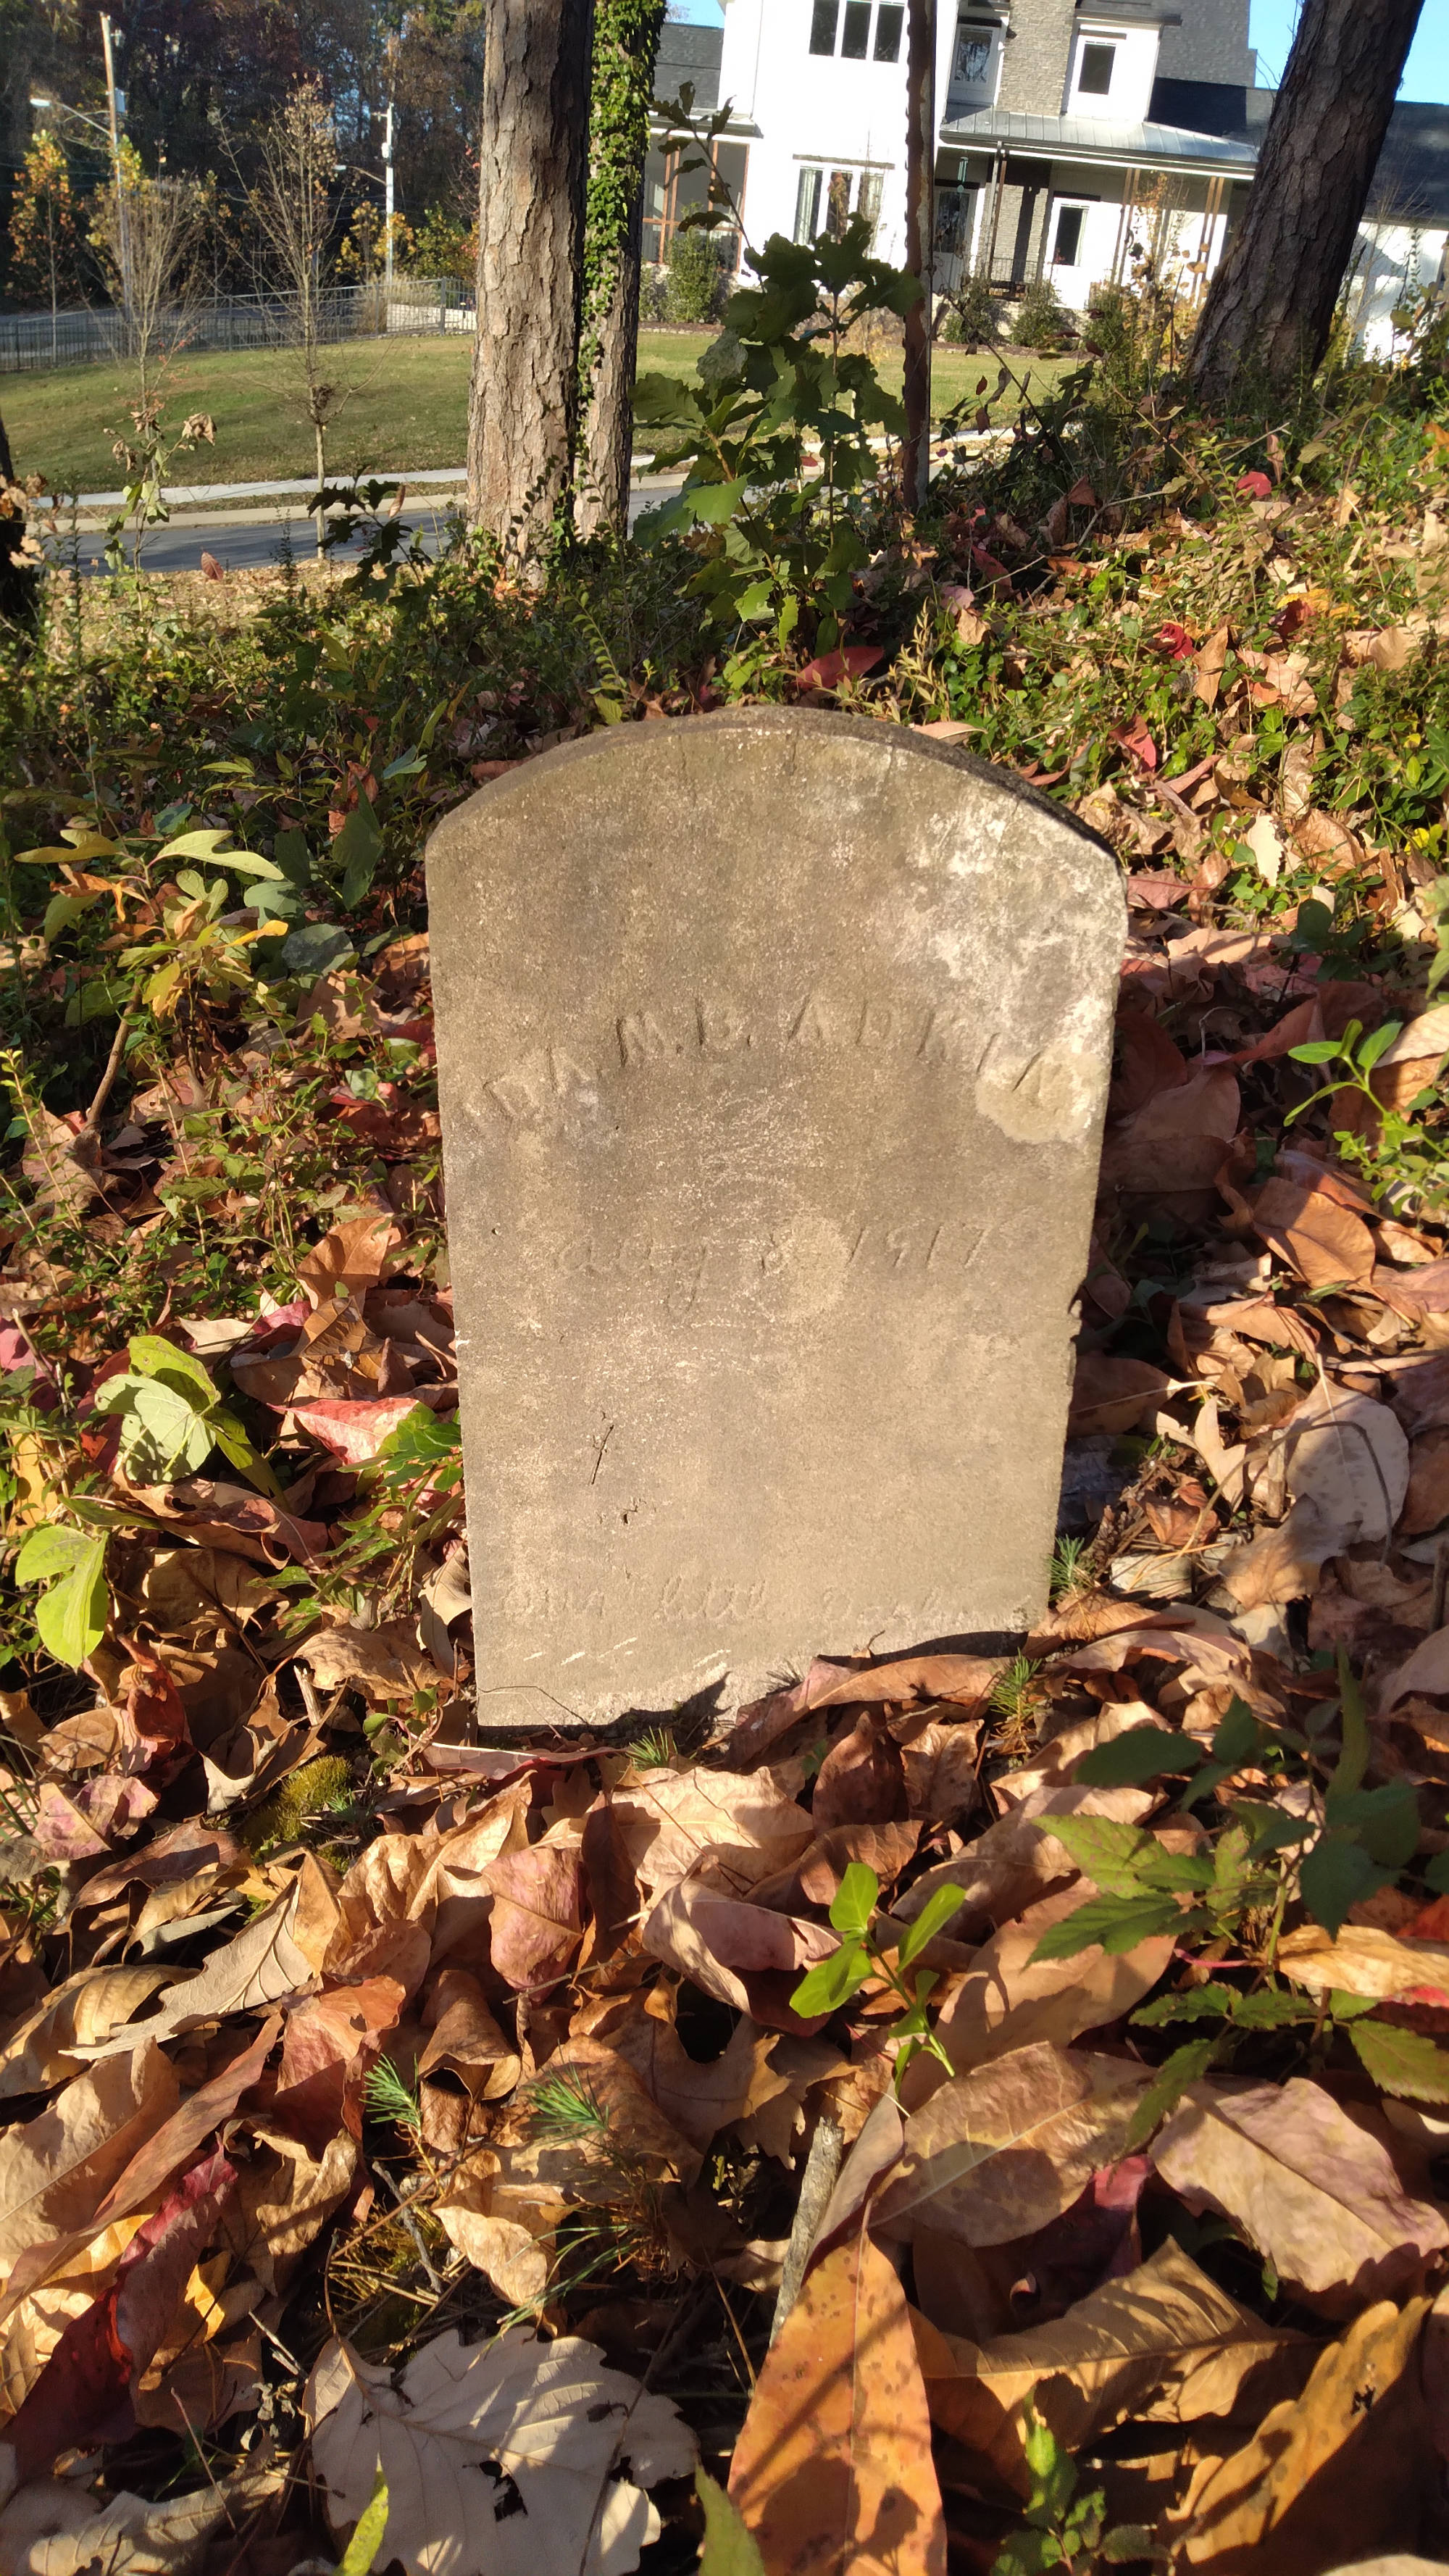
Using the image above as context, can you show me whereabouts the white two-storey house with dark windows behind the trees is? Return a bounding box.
[643,0,1449,345]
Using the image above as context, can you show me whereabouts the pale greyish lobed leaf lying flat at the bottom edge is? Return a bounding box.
[306,2329,695,2576]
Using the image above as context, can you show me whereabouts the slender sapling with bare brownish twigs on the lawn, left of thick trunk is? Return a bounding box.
[252,80,350,554]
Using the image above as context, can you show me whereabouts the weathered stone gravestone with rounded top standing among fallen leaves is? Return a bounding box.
[427,709,1124,1728]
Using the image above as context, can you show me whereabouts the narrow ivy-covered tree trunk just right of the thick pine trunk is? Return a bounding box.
[579,0,667,535]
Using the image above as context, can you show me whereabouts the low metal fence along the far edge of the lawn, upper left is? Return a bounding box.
[0,278,474,376]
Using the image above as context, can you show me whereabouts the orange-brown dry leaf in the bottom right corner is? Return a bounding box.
[1174,2298,1434,2576]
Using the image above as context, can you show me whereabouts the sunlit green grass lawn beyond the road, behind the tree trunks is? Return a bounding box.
[0,330,1058,492]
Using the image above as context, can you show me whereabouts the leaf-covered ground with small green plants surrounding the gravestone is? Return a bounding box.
[0,373,1449,2576]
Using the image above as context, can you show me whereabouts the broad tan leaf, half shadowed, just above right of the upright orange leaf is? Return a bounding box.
[870,2043,1148,2246]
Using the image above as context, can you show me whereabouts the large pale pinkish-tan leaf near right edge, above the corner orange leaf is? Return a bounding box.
[1151,2076,1449,2316]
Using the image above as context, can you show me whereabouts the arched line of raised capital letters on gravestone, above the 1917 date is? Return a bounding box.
[484,992,993,1126]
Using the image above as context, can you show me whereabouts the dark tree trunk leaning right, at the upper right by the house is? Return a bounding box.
[1187,0,1421,404]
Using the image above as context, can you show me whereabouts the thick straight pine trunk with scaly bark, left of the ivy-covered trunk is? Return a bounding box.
[469,0,595,546]
